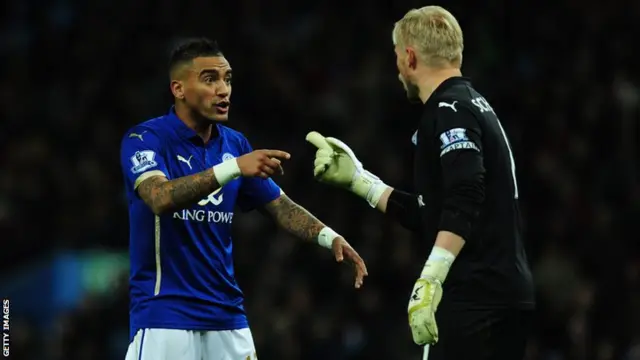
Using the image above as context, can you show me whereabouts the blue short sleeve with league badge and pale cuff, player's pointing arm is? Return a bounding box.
[120,129,169,190]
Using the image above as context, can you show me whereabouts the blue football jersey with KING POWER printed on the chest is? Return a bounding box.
[120,108,281,337]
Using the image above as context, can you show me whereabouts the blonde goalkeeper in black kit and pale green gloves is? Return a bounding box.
[307,6,534,360]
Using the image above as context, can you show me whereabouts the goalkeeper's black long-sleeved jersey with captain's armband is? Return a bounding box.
[387,77,534,308]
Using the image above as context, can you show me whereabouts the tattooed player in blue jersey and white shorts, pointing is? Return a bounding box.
[121,39,367,360]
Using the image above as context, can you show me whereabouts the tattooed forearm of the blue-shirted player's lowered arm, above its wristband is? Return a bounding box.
[265,195,325,241]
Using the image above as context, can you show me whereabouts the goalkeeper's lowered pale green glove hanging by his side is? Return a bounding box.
[407,246,455,345]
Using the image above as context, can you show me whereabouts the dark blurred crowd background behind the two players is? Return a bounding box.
[0,0,640,360]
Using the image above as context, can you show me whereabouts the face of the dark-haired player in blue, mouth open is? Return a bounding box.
[184,56,231,121]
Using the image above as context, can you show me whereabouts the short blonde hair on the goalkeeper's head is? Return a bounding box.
[392,6,464,67]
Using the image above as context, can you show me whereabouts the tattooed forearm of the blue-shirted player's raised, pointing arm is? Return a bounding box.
[138,169,220,214]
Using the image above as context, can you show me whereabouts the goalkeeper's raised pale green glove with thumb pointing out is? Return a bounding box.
[306,131,388,208]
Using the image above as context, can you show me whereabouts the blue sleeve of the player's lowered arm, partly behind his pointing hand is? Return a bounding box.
[237,138,283,211]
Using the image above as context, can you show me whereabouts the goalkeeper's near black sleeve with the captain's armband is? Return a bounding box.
[435,104,485,240]
